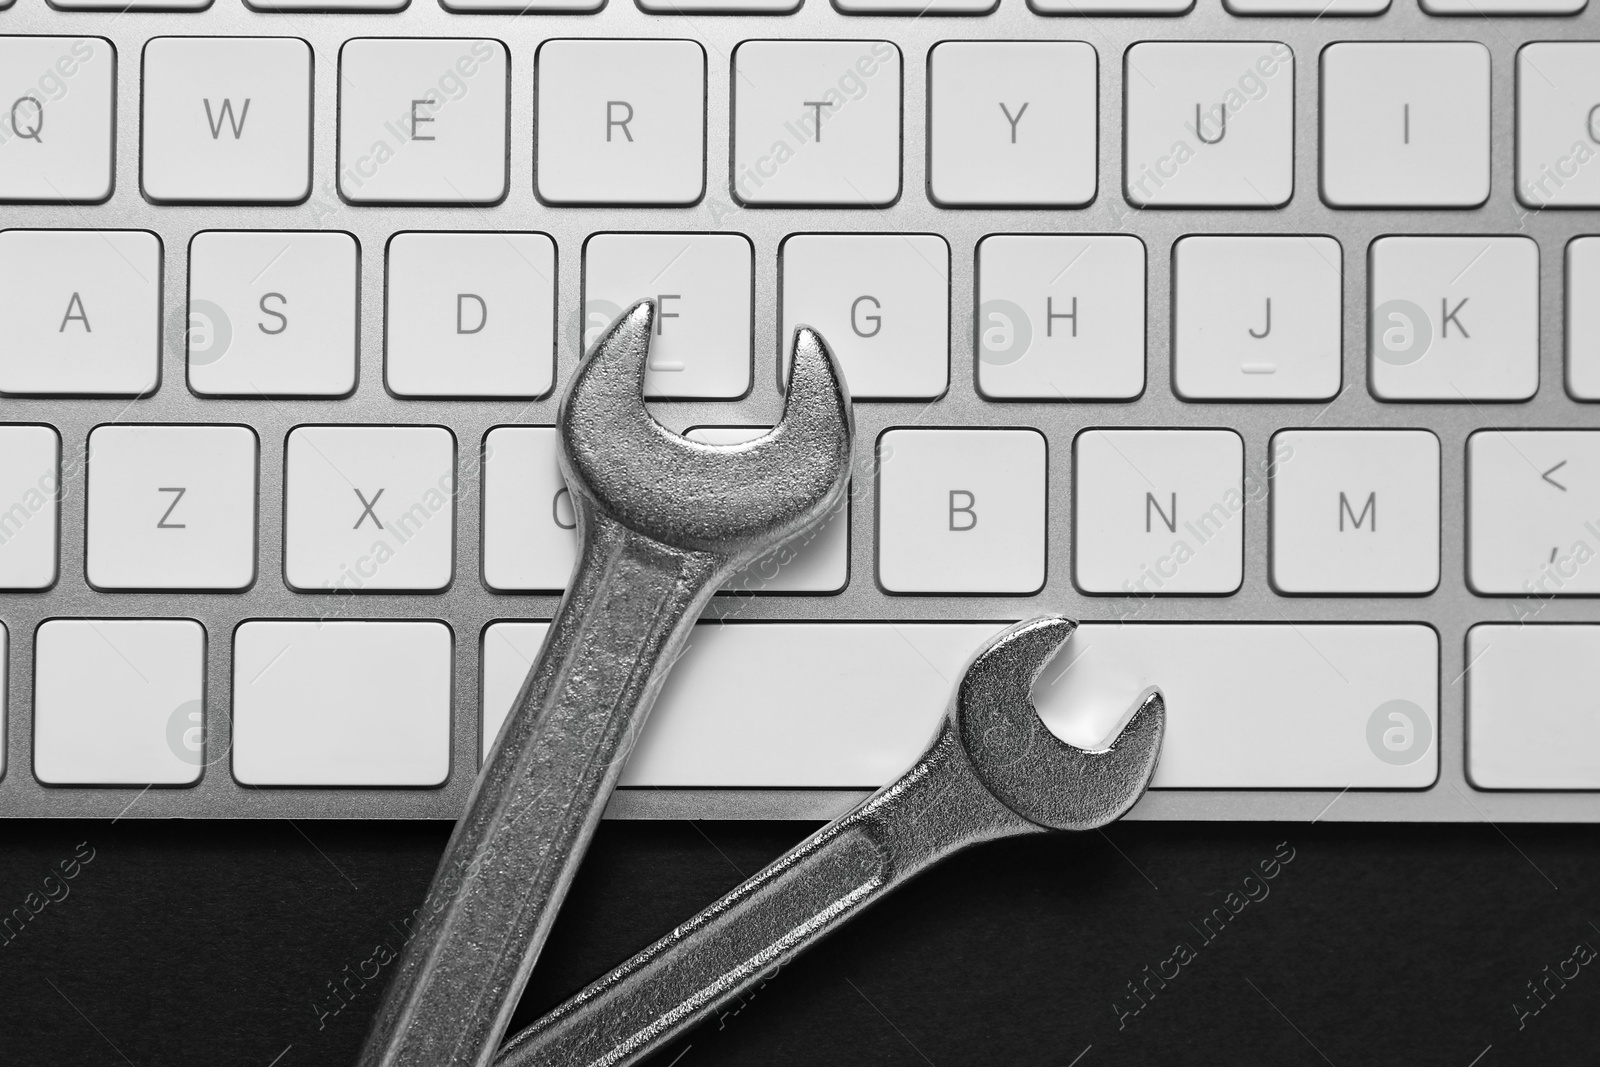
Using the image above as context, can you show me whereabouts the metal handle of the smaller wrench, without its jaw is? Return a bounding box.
[494,720,1038,1067]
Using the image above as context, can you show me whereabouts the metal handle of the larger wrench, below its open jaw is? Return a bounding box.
[360,511,723,1067]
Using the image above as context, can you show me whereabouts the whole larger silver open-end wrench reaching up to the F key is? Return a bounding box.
[360,301,854,1067]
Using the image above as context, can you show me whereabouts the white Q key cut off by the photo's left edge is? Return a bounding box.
[0,37,117,203]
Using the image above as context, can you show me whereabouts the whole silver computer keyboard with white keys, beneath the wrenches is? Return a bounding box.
[0,0,1600,822]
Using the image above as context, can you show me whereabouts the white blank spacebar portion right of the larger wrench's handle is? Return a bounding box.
[621,622,1438,789]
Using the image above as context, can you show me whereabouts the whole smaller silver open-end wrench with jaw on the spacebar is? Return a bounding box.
[494,616,1166,1067]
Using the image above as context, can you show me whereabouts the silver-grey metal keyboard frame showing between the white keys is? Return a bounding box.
[0,0,1600,822]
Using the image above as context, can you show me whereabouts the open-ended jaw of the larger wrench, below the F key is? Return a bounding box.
[557,299,854,563]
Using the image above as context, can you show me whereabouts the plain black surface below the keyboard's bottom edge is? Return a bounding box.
[0,819,1600,1067]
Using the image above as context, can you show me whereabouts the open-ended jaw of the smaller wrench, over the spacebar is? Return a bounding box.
[950,616,1166,830]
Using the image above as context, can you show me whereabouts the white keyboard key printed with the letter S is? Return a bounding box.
[187,230,360,397]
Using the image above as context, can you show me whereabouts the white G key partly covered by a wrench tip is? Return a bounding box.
[778,234,950,400]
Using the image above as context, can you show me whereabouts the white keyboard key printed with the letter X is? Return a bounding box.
[283,426,456,595]
